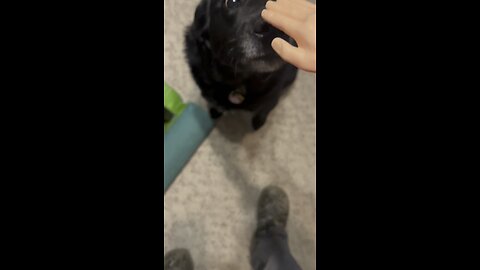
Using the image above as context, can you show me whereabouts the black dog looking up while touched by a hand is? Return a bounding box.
[186,0,297,130]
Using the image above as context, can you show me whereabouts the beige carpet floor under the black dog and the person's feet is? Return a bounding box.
[163,0,316,270]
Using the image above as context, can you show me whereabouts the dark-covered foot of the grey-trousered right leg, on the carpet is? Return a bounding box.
[257,186,290,232]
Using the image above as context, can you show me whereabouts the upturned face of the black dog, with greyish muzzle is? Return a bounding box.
[206,0,293,72]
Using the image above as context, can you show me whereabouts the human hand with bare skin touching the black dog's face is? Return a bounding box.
[262,0,317,72]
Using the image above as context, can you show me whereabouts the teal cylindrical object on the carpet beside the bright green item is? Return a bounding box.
[163,103,214,193]
